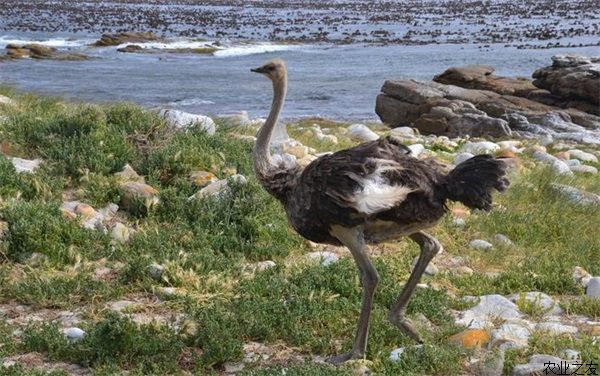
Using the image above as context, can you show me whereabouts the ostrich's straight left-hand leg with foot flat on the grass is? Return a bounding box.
[327,226,379,364]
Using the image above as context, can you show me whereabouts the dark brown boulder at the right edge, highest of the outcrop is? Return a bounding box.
[533,55,600,115]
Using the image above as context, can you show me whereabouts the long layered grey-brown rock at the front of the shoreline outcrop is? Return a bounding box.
[375,62,600,144]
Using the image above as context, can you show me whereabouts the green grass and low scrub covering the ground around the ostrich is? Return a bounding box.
[0,88,600,375]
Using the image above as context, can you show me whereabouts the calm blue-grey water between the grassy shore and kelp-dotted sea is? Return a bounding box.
[0,35,599,120]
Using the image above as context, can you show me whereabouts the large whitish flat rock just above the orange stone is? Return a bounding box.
[456,295,522,329]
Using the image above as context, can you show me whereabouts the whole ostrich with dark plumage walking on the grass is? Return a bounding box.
[251,59,508,364]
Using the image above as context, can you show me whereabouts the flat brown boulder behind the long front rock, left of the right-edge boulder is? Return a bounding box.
[433,65,537,97]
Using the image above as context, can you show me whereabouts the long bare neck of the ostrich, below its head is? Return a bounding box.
[253,75,287,179]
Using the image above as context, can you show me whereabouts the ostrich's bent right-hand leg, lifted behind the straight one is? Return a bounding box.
[388,231,442,343]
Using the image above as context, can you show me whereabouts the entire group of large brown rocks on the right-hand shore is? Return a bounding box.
[375,56,600,144]
